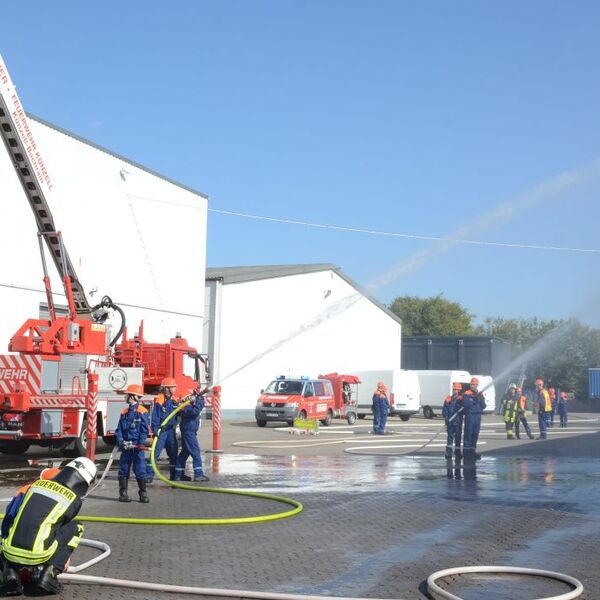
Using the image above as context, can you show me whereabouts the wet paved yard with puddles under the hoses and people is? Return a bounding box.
[0,414,600,600]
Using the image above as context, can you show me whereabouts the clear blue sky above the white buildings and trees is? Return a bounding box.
[0,0,600,326]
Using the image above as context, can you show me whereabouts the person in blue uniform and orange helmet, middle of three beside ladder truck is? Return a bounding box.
[146,377,179,483]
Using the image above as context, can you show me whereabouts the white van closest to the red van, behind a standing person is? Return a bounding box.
[352,369,421,421]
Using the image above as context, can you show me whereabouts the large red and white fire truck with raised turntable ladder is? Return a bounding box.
[0,57,209,455]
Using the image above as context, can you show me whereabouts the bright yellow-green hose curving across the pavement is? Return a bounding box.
[76,400,304,525]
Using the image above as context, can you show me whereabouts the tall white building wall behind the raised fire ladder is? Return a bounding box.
[0,120,207,353]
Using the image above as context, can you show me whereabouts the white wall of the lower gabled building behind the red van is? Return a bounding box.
[214,271,401,411]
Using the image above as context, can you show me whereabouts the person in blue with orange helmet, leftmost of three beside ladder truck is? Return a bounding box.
[115,383,150,503]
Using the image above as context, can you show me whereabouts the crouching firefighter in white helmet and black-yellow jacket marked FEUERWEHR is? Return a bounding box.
[1,457,96,596]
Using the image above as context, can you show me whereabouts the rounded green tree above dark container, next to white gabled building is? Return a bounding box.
[390,294,473,335]
